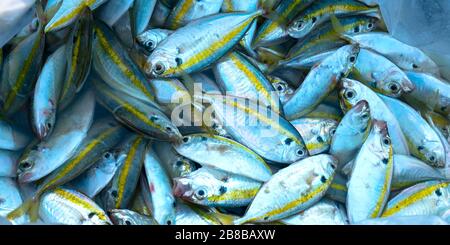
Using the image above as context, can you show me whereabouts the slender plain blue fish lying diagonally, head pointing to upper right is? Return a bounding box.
[284,45,359,120]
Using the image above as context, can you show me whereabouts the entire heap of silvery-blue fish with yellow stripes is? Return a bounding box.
[0,0,450,225]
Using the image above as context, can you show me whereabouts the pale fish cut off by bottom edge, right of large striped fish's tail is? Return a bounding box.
[280,198,348,225]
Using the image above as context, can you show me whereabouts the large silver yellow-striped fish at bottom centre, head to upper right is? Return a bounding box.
[234,154,337,224]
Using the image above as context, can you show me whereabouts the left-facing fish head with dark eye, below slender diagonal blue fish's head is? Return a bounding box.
[339,78,364,111]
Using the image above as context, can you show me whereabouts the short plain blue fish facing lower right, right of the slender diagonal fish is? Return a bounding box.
[355,49,415,97]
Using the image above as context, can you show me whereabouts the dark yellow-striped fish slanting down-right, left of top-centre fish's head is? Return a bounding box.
[93,21,154,103]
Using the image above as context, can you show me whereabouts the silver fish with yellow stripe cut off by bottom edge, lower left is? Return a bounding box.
[39,188,112,225]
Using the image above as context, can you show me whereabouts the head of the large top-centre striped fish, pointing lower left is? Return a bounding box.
[144,49,178,78]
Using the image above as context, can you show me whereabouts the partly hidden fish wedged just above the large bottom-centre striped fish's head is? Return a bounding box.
[291,118,338,155]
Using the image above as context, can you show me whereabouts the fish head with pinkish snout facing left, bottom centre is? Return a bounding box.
[173,167,226,206]
